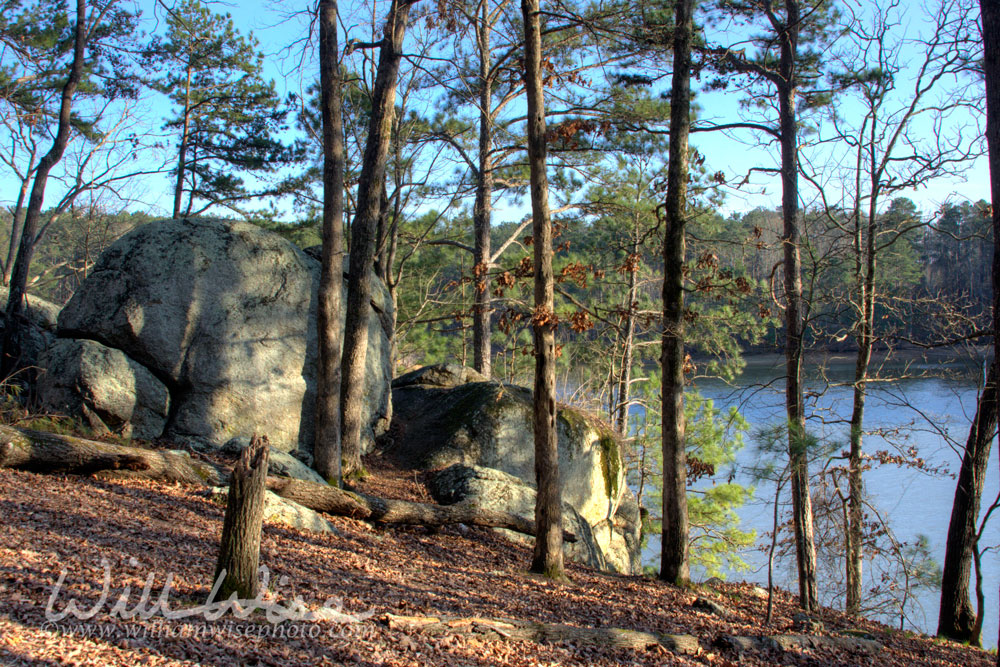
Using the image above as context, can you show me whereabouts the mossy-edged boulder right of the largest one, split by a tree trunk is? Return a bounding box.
[386,365,640,573]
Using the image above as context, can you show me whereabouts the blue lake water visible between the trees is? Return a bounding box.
[643,355,1000,647]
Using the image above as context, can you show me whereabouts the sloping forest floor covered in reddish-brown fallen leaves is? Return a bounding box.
[0,461,995,667]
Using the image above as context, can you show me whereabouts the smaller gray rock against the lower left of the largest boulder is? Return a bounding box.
[37,339,170,439]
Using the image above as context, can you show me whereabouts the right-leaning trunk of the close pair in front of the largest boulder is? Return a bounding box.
[340,0,412,479]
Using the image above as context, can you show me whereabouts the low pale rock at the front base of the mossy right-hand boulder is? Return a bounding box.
[430,464,608,570]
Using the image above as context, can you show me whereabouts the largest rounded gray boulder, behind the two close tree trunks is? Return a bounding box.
[41,219,392,454]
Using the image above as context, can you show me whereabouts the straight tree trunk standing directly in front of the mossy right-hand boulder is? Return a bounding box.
[521,0,566,578]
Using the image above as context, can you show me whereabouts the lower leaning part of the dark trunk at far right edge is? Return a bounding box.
[938,364,997,642]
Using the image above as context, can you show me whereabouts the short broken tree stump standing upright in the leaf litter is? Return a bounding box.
[214,435,268,600]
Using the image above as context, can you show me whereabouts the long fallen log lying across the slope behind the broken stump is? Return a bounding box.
[0,425,577,542]
